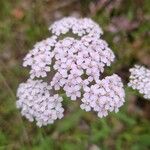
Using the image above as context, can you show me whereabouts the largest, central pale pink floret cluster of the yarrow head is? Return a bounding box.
[51,36,115,100]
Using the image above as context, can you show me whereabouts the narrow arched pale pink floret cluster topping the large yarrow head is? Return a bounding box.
[49,17,103,38]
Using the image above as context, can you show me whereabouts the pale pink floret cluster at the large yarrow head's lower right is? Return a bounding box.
[80,74,125,118]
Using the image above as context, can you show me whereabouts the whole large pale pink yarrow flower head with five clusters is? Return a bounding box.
[17,17,125,126]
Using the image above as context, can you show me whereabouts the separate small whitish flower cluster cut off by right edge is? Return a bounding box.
[128,65,150,99]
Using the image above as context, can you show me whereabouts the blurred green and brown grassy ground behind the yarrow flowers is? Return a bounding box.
[0,0,150,150]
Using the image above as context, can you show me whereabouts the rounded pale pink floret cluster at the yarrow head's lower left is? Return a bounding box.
[17,79,64,127]
